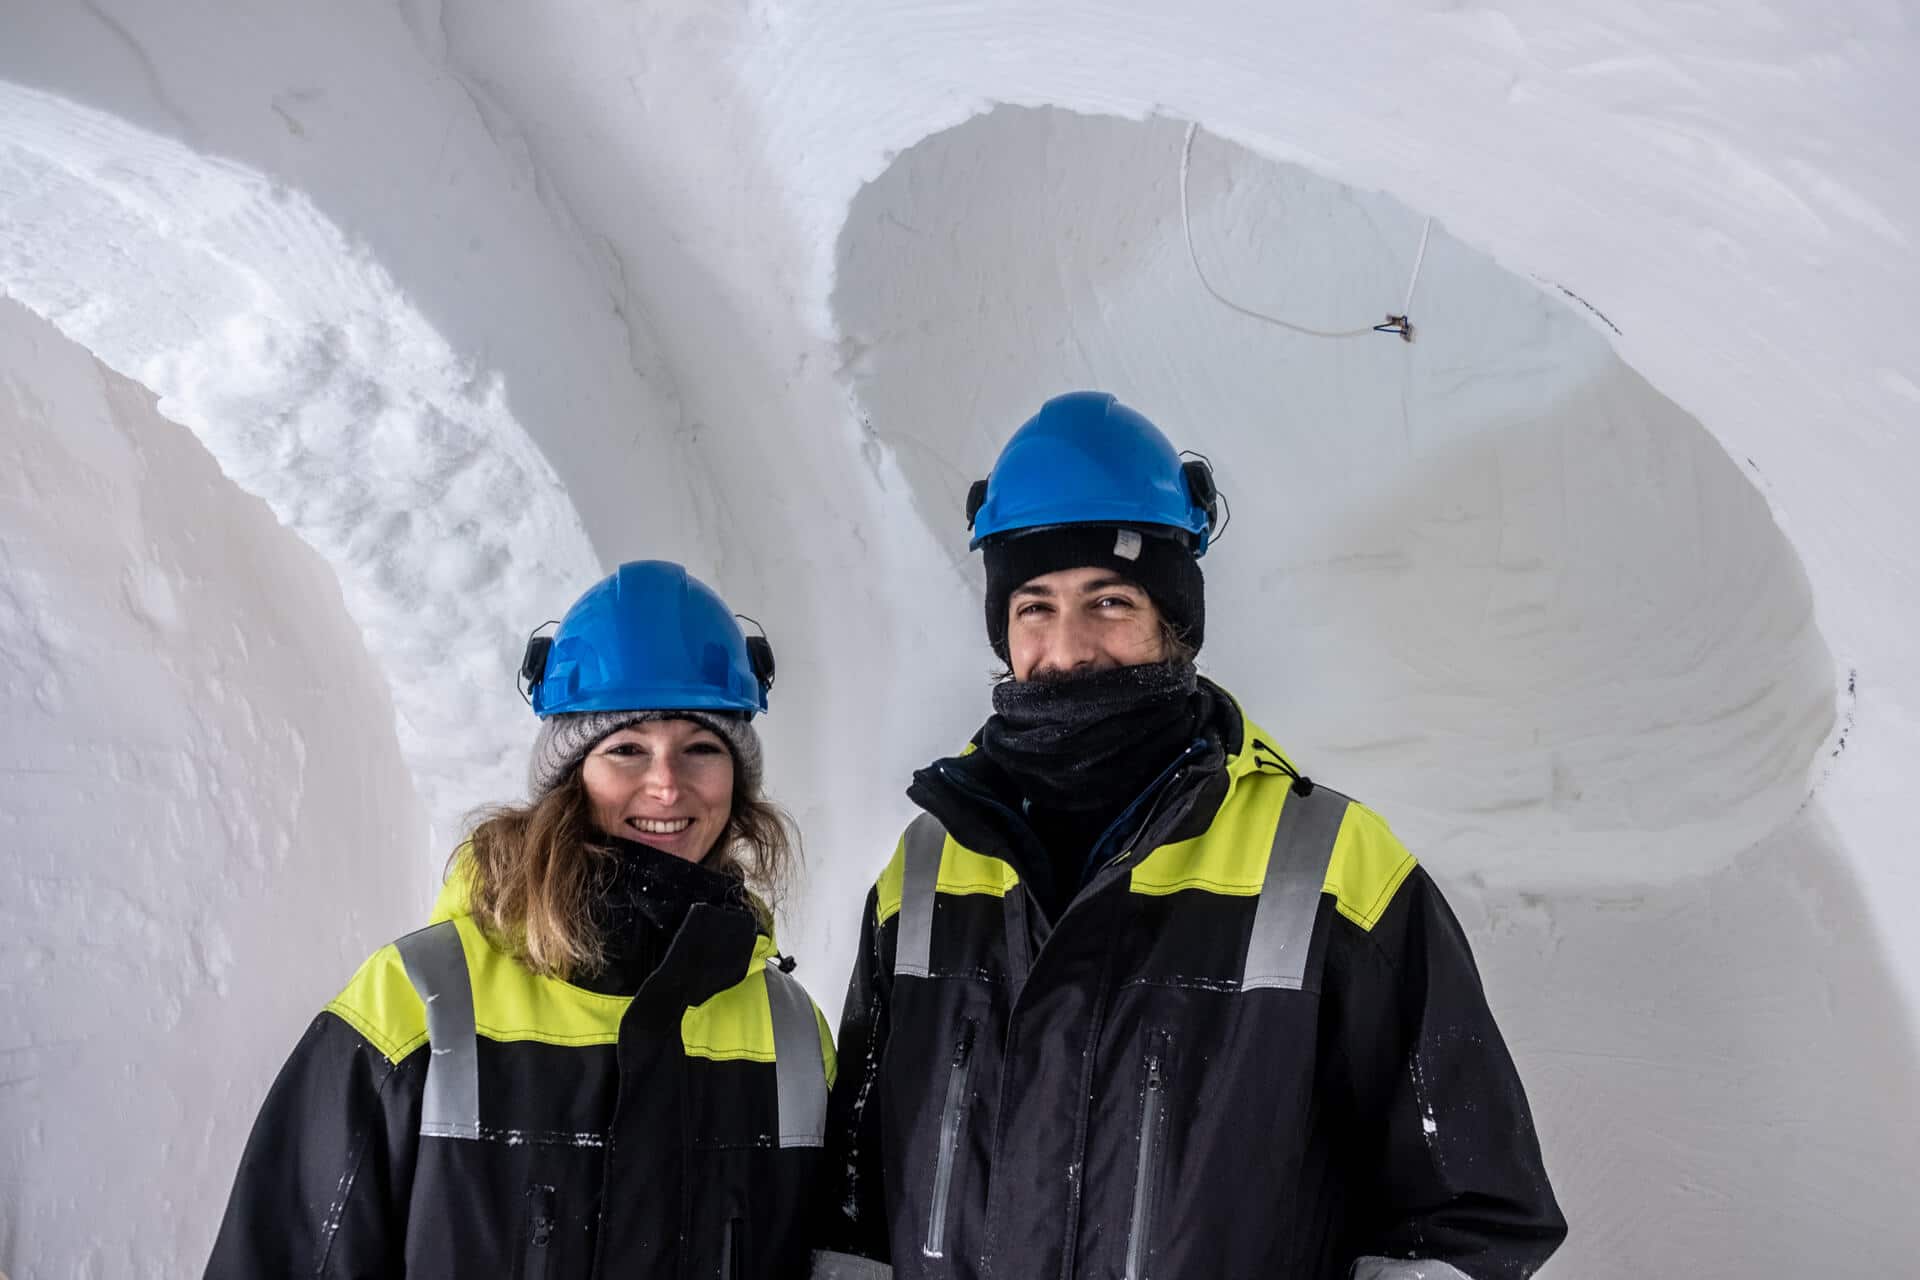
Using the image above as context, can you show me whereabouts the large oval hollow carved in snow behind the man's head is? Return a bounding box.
[835,107,1836,885]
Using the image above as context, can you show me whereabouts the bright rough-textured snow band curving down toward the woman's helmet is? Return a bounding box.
[0,84,599,848]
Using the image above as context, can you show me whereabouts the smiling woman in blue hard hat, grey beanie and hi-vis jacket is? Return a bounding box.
[207,560,833,1278]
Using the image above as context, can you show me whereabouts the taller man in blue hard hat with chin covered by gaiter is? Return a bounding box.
[816,391,1567,1280]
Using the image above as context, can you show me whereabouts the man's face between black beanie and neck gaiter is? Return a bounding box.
[1006,568,1167,679]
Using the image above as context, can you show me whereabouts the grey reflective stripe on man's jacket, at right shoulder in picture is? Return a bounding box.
[1240,787,1348,990]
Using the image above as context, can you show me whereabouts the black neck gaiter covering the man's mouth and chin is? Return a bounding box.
[979,662,1198,821]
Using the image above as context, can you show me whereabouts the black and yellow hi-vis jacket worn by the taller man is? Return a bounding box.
[814,687,1567,1280]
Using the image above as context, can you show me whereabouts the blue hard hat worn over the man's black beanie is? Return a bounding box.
[968,391,1215,557]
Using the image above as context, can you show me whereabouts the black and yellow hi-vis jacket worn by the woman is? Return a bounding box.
[207,859,833,1280]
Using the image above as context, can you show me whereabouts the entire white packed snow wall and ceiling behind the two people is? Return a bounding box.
[0,0,1920,1276]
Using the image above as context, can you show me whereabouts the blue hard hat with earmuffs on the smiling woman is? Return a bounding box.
[520,560,774,718]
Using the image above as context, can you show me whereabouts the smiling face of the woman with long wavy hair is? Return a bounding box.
[580,720,733,862]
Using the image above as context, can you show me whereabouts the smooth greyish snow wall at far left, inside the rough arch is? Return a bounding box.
[0,299,426,1276]
